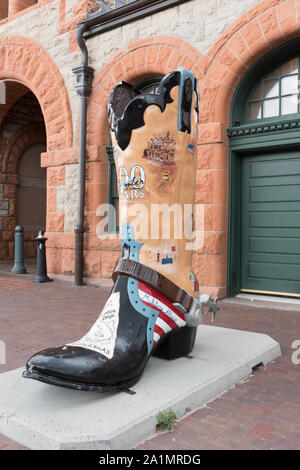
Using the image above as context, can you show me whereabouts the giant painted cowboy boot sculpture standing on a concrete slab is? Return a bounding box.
[24,69,217,391]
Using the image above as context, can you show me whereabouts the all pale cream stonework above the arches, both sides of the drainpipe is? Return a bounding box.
[0,0,259,144]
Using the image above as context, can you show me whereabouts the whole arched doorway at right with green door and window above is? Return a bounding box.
[228,40,300,297]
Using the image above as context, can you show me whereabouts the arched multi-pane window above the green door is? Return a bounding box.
[245,57,300,121]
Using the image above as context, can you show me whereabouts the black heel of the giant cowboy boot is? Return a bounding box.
[153,326,197,360]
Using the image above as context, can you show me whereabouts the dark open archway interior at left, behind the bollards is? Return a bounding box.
[0,81,46,261]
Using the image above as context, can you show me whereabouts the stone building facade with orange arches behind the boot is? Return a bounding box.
[0,0,300,297]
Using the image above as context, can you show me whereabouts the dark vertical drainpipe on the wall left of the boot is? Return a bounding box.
[73,23,94,286]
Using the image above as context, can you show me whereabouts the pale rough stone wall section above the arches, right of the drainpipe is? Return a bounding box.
[88,0,260,73]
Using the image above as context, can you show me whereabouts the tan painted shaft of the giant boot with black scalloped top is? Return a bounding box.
[109,69,198,297]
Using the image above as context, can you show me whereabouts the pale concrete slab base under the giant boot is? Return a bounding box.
[0,325,281,450]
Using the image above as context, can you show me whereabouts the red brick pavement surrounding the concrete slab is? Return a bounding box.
[0,273,300,450]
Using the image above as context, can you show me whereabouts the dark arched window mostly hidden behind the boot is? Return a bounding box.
[106,76,162,232]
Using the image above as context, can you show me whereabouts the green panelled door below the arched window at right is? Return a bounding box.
[241,151,300,296]
